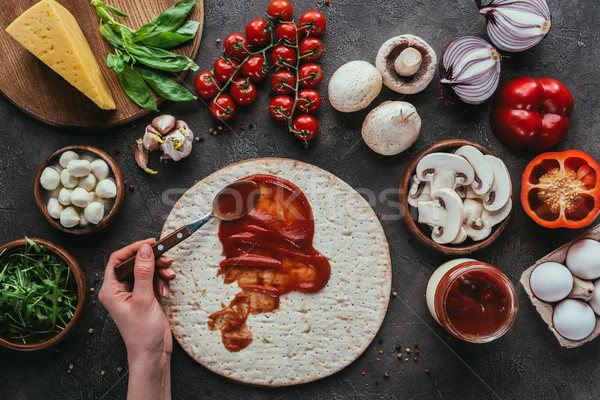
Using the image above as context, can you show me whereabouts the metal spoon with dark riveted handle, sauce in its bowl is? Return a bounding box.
[115,181,260,281]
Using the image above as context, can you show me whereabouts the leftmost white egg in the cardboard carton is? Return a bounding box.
[529,262,573,302]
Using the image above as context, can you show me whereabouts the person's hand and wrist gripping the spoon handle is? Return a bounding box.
[98,239,175,399]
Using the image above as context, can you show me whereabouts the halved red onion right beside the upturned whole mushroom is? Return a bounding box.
[439,36,500,104]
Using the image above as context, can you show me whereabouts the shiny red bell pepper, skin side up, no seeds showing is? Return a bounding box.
[490,77,573,151]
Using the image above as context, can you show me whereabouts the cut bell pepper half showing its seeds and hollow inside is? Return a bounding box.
[521,150,600,229]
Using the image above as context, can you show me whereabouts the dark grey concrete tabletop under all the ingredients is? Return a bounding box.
[0,0,600,400]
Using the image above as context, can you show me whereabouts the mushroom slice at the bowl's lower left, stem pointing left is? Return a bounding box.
[417,188,462,244]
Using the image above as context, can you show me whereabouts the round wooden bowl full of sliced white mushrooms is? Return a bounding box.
[399,139,513,255]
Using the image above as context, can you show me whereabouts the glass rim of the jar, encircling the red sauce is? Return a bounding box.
[434,261,519,343]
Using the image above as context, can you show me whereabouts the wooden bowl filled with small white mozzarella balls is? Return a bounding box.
[34,145,125,235]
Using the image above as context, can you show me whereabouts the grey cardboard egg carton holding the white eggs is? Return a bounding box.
[521,225,600,349]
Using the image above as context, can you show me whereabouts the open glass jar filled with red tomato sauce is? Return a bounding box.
[426,258,518,343]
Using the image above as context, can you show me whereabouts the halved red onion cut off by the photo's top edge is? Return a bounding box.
[475,0,552,52]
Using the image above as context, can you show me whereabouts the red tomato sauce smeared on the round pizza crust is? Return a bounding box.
[208,175,331,352]
